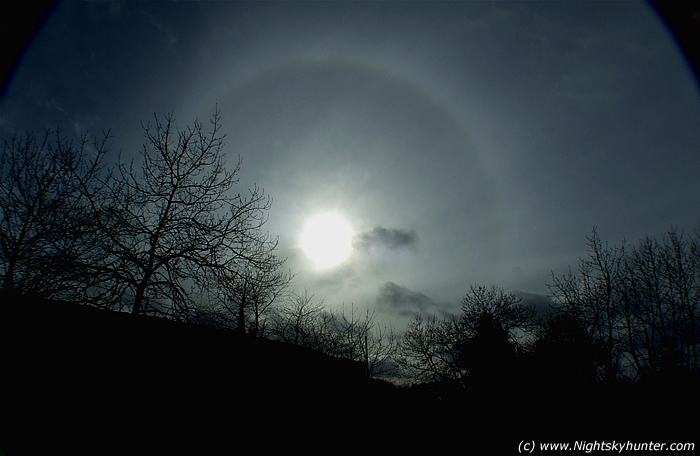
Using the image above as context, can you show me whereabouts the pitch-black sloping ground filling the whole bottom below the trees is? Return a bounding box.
[0,297,700,456]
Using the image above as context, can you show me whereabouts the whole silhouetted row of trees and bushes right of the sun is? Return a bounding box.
[399,228,700,386]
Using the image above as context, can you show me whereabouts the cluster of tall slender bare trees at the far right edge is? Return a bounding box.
[550,225,700,380]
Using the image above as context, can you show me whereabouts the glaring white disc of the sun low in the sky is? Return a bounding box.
[301,213,352,268]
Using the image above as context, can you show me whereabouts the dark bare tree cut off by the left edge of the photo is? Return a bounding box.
[0,130,109,299]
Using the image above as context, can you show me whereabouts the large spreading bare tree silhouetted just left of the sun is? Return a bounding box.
[86,110,283,319]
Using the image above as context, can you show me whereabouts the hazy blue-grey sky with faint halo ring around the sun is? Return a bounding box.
[0,1,700,324]
